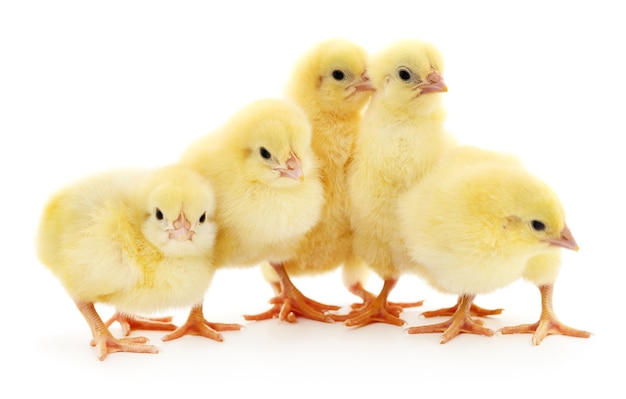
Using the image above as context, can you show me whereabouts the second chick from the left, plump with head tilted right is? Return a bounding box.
[173,99,324,334]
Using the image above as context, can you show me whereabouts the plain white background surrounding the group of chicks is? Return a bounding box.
[0,0,626,397]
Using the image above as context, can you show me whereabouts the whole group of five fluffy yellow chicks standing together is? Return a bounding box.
[37,39,590,360]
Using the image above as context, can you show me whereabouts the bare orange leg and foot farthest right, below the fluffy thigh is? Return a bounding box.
[498,284,591,345]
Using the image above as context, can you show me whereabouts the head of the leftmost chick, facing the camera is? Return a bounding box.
[139,165,217,256]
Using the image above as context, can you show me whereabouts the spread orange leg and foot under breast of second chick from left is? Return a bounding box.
[244,263,340,323]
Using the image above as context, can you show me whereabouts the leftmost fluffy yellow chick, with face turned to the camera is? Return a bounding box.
[36,165,217,360]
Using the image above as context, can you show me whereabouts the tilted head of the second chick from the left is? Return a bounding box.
[227,99,317,188]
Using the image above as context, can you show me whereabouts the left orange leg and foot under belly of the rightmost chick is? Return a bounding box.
[406,295,495,344]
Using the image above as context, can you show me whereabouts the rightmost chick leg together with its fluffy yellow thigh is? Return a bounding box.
[498,252,591,345]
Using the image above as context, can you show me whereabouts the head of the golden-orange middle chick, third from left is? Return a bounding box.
[287,38,374,114]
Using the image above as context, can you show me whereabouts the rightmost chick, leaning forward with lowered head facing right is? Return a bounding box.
[398,146,582,343]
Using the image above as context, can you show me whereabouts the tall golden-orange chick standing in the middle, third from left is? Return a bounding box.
[245,38,373,321]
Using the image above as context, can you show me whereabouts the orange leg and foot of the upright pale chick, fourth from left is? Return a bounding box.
[344,279,404,327]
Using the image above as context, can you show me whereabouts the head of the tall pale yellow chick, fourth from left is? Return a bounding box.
[368,39,448,116]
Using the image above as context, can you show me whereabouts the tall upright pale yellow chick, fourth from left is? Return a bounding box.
[345,39,455,326]
